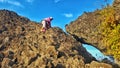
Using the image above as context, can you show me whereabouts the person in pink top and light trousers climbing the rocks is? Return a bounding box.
[41,17,53,32]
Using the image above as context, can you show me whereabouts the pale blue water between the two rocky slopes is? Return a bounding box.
[82,44,114,62]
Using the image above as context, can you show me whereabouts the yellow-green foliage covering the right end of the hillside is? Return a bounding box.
[100,6,120,61]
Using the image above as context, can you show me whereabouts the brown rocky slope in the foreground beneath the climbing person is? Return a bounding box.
[0,10,112,68]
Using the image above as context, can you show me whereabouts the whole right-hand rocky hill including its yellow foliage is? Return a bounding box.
[66,0,120,64]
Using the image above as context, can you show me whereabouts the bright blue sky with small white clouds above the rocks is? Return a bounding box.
[0,0,113,29]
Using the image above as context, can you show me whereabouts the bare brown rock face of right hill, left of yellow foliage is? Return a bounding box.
[66,10,105,50]
